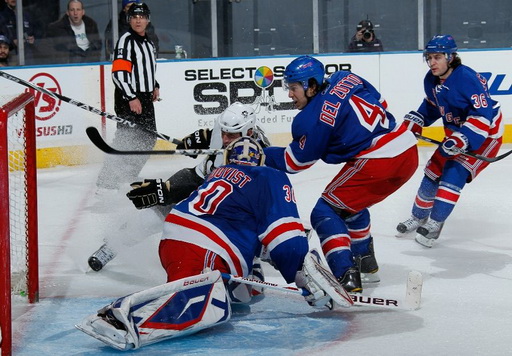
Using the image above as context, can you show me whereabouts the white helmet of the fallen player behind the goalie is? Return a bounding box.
[217,101,256,135]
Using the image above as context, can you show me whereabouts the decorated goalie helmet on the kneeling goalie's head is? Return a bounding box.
[224,136,265,167]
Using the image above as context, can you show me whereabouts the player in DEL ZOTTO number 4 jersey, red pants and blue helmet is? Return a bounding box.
[265,56,418,292]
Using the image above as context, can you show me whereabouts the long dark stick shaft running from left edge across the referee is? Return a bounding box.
[0,71,180,144]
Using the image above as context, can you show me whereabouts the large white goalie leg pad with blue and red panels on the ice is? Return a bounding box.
[76,271,231,351]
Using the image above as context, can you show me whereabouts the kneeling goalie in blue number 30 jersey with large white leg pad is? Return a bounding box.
[77,137,352,350]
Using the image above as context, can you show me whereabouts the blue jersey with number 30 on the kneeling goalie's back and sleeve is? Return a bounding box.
[162,164,308,283]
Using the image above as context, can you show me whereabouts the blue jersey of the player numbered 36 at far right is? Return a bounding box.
[418,64,504,151]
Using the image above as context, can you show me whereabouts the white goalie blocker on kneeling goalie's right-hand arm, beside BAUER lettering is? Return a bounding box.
[301,250,354,308]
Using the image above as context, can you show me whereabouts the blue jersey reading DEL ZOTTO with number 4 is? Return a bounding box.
[264,71,417,173]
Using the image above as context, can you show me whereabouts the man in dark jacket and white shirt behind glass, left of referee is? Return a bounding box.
[47,0,101,63]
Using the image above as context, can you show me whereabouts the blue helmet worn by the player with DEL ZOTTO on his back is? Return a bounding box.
[283,56,325,90]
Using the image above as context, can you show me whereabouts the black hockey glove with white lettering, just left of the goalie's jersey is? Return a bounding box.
[126,179,172,209]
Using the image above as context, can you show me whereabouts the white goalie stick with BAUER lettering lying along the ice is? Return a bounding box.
[222,271,423,310]
